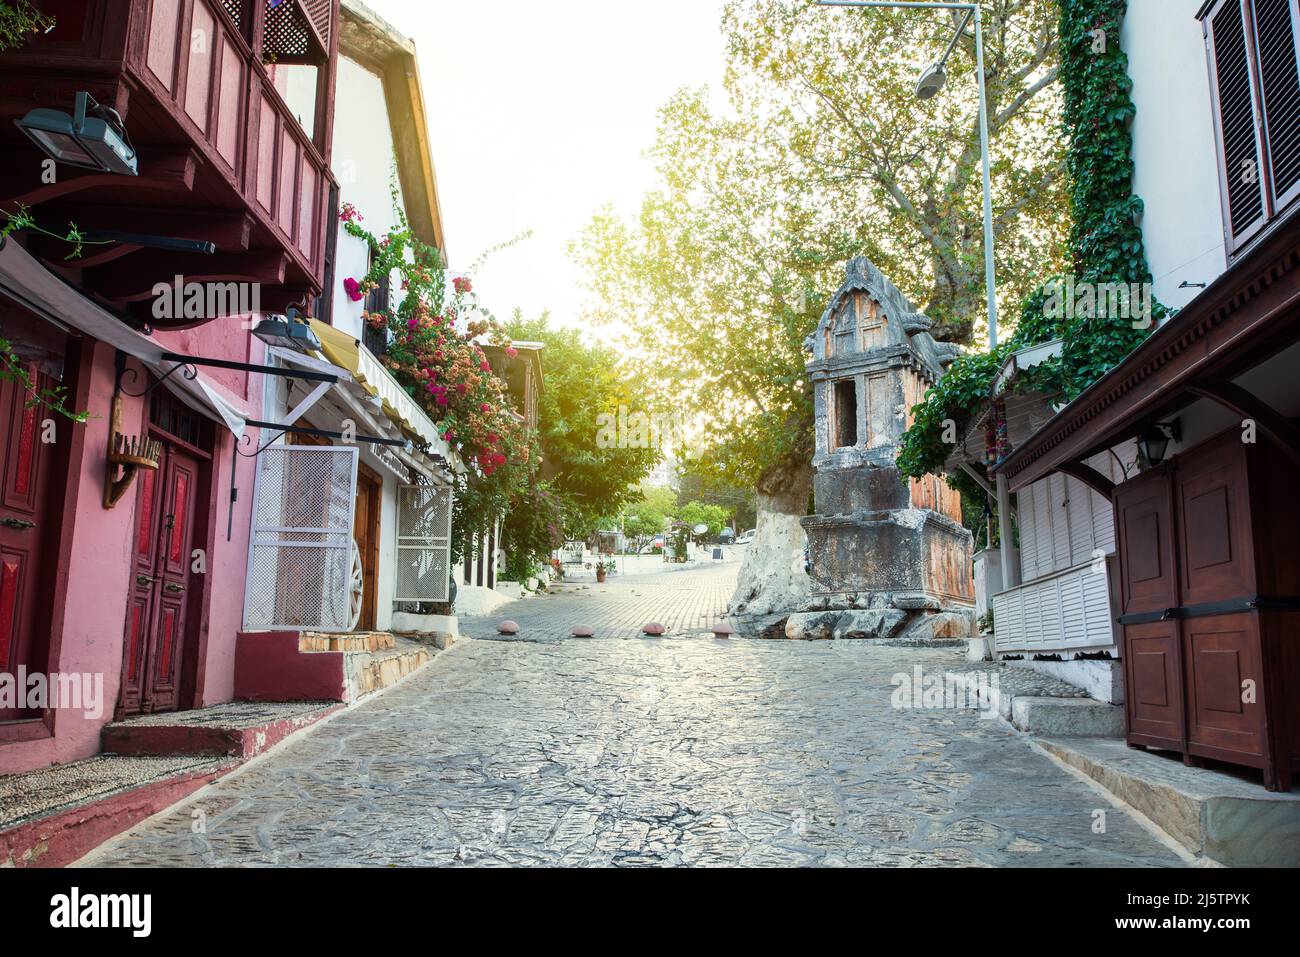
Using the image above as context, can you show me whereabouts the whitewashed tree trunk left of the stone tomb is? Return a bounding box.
[728,459,813,615]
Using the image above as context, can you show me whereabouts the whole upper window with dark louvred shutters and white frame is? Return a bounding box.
[1205,0,1300,252]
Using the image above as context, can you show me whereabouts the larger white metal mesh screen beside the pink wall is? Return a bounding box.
[244,446,358,632]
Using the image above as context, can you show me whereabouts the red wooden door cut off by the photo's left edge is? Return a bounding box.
[0,368,59,720]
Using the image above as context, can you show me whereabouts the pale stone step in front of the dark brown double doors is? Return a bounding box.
[1037,737,1300,867]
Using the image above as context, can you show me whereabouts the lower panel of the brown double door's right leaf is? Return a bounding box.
[1182,612,1265,758]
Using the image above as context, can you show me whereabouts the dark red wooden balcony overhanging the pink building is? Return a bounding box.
[0,0,338,326]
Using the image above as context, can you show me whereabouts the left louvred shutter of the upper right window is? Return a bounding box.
[1206,0,1268,251]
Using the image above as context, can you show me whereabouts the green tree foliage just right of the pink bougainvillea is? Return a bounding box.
[504,312,660,538]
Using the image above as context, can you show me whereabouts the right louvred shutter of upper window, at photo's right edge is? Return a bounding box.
[1255,0,1300,209]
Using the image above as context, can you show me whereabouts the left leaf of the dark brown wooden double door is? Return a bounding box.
[1114,469,1186,750]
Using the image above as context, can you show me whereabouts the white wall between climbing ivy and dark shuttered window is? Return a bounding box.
[1121,0,1227,308]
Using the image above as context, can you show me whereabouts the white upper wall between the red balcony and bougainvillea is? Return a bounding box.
[332,56,402,338]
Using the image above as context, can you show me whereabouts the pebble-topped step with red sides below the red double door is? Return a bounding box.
[100,701,342,759]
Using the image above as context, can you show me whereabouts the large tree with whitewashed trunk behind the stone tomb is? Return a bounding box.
[575,0,1069,614]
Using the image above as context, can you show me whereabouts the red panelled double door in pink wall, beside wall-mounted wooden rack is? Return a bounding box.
[120,446,199,714]
